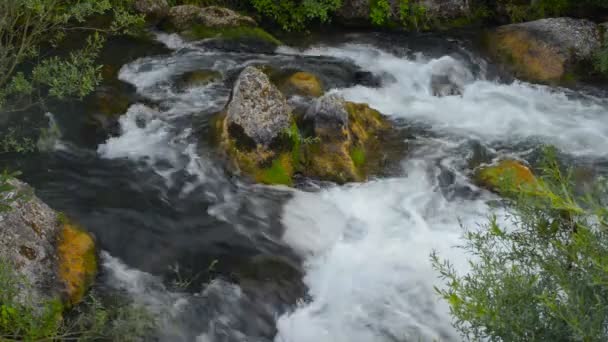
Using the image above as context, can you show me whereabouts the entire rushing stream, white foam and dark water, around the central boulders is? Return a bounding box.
[3,30,608,342]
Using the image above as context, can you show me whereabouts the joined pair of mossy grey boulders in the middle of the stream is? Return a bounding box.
[214,67,391,186]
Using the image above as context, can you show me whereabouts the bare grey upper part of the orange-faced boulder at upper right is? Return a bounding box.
[499,18,601,60]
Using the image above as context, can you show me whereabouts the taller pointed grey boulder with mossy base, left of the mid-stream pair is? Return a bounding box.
[215,67,297,185]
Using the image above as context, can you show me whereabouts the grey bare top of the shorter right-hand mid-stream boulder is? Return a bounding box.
[304,94,348,137]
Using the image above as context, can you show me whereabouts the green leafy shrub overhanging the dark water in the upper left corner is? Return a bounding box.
[0,0,144,109]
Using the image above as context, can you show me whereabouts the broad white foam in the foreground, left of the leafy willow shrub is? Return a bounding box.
[275,160,496,342]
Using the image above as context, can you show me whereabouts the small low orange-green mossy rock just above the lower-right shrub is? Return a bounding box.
[476,160,536,192]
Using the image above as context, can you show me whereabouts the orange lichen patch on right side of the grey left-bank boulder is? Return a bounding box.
[57,222,97,305]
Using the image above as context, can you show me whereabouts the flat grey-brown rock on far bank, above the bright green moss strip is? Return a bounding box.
[167,5,257,31]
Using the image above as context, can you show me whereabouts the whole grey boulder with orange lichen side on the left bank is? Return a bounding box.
[0,180,97,306]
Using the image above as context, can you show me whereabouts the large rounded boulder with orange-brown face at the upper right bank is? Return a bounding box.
[488,18,601,83]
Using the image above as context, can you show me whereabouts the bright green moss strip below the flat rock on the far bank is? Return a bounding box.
[184,25,282,45]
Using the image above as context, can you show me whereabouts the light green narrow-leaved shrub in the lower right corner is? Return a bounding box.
[432,150,608,341]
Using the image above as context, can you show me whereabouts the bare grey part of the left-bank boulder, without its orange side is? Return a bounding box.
[0,180,62,302]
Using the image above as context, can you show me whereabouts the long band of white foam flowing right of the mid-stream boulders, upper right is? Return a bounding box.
[282,44,608,157]
